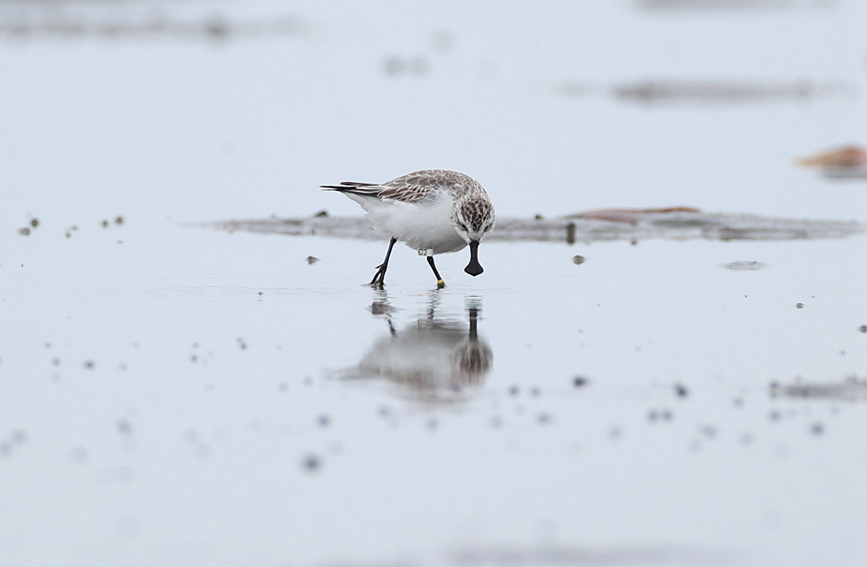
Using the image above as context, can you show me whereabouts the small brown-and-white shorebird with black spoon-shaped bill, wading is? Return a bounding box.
[322,169,494,288]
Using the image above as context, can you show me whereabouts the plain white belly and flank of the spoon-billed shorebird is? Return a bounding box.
[347,194,467,254]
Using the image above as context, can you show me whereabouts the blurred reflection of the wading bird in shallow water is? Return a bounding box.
[347,292,493,404]
